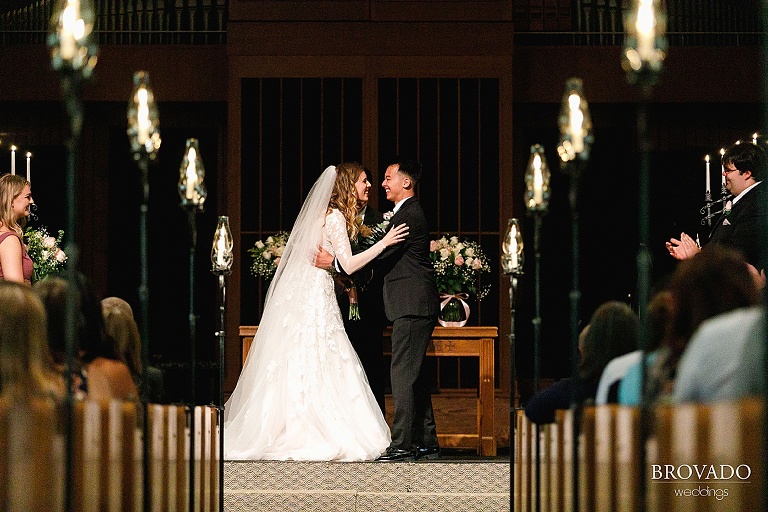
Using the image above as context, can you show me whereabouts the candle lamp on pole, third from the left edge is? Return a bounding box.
[179,138,208,510]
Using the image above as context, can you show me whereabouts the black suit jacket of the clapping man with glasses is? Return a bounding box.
[708,183,768,270]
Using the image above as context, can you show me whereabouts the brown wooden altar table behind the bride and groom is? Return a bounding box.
[240,325,499,457]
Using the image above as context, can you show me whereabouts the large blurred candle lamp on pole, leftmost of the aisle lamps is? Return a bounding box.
[48,0,98,510]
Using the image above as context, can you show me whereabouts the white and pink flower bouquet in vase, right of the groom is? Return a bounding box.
[429,236,491,301]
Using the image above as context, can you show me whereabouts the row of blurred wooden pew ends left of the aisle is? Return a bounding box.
[0,401,220,512]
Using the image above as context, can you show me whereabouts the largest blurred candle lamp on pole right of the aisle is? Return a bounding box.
[622,0,664,510]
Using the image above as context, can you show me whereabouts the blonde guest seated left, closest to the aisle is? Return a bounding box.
[101,297,164,404]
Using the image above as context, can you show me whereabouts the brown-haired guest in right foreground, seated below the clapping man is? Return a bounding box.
[646,244,761,401]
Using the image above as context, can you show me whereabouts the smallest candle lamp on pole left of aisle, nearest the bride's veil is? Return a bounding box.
[211,215,234,512]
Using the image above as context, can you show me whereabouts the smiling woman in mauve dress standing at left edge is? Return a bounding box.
[0,174,34,284]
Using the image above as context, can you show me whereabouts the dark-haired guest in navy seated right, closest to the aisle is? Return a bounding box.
[525,301,639,425]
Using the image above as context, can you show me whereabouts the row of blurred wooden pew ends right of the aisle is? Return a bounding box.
[513,399,766,512]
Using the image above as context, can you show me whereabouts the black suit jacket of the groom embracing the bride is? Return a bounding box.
[379,196,440,321]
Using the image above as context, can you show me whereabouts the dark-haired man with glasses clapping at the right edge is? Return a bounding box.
[666,140,768,271]
